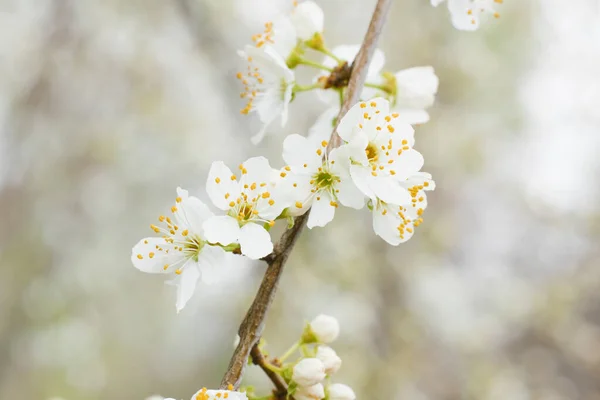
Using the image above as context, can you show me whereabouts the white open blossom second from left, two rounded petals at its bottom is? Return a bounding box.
[204,157,288,260]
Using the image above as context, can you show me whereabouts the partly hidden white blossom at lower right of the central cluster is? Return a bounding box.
[373,172,435,246]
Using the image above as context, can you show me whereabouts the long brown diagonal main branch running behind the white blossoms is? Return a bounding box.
[221,0,392,389]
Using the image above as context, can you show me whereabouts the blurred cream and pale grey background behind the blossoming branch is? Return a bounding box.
[0,0,600,400]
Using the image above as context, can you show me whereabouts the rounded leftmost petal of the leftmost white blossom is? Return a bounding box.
[131,237,182,274]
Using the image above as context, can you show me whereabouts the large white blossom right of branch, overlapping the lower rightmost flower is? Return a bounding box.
[337,98,423,204]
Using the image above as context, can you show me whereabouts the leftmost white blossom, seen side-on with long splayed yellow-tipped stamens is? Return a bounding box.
[131,188,225,312]
